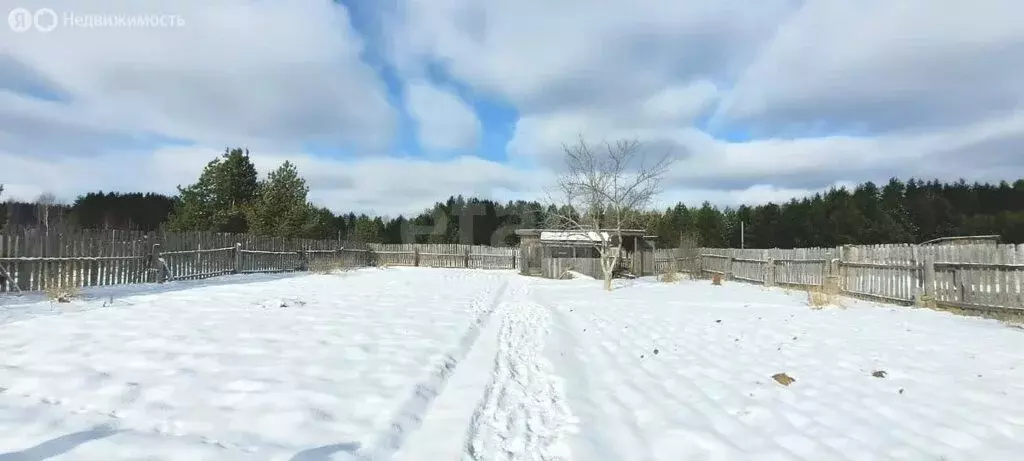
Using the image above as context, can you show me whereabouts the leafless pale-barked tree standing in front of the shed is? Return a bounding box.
[548,136,672,291]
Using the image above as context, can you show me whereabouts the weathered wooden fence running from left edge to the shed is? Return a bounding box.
[0,229,518,293]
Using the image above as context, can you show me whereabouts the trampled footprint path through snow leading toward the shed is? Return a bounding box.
[466,280,574,461]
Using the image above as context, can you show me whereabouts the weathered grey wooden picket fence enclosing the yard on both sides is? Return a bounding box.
[0,229,1024,309]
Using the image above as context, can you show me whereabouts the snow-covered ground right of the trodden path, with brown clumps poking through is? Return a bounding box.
[534,281,1024,461]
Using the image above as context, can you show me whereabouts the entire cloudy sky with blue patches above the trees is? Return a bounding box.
[0,0,1024,215]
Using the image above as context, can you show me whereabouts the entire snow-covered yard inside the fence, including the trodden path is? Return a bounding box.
[0,268,1024,461]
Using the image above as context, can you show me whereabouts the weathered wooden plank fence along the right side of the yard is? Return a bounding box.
[654,244,1024,309]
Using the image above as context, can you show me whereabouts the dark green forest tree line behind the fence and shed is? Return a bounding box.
[0,149,1024,248]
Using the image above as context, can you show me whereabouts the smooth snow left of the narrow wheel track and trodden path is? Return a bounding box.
[0,268,508,461]
